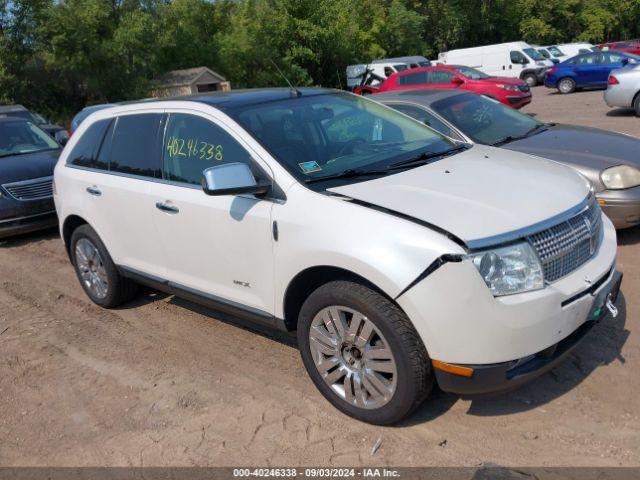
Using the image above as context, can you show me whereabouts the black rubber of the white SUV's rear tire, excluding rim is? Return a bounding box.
[69,224,138,308]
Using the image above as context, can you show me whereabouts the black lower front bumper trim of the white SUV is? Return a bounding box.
[434,270,622,396]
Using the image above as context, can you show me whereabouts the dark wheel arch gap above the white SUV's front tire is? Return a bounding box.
[283,265,399,331]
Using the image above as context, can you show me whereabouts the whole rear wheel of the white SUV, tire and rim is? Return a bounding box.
[70,225,137,308]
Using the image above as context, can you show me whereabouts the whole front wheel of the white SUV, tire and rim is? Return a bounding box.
[298,281,434,425]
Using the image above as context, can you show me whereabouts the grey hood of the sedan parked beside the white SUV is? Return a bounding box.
[502,125,640,173]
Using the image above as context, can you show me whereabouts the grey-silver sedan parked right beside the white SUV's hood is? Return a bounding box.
[371,89,640,228]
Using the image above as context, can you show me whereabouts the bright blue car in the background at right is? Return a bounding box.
[544,52,640,93]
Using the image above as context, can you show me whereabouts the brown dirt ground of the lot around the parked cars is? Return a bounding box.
[0,87,640,466]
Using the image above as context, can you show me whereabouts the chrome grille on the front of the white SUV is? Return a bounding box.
[528,201,602,282]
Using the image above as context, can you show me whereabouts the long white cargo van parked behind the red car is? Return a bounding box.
[438,42,553,87]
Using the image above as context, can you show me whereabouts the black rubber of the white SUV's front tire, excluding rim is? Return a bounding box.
[297,281,435,425]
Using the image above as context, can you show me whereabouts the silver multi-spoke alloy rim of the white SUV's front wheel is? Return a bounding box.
[309,305,398,409]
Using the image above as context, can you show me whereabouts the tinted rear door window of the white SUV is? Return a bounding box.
[109,113,162,178]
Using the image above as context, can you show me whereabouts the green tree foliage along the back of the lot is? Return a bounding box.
[0,0,640,124]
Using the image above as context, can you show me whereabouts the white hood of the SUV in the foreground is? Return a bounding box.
[329,145,590,243]
